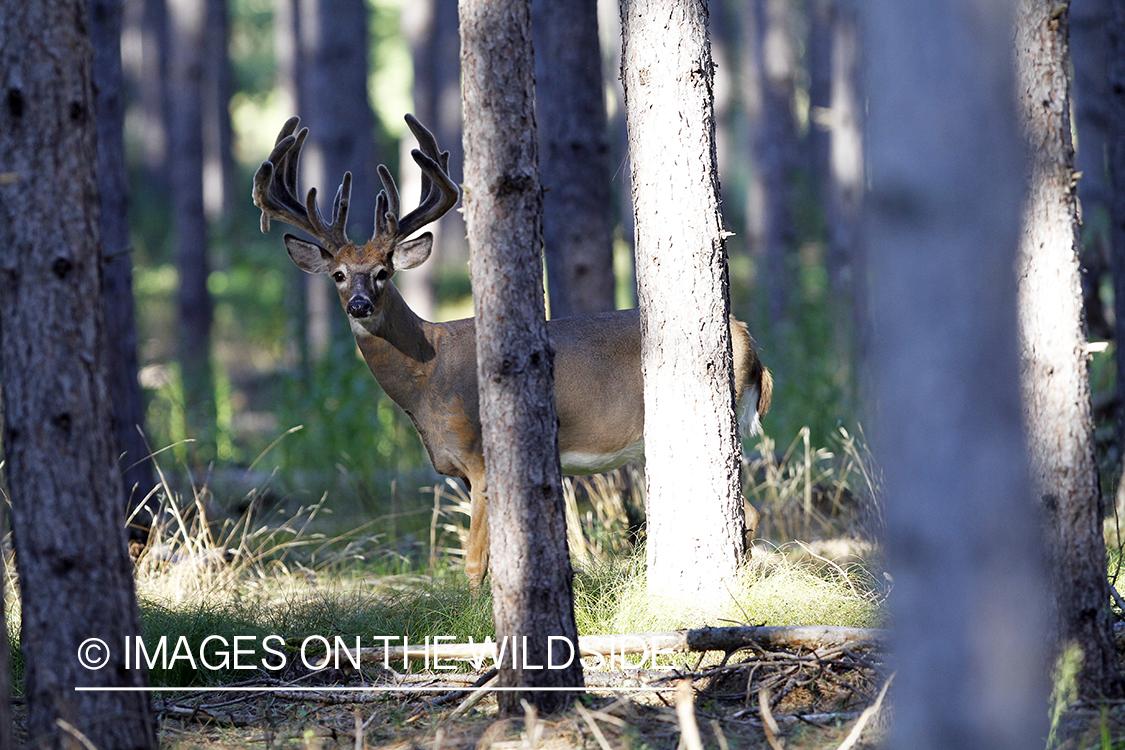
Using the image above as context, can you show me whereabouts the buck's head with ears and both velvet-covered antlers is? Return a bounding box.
[253,115,460,324]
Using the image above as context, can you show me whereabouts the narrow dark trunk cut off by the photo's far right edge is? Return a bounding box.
[1106,2,1125,452]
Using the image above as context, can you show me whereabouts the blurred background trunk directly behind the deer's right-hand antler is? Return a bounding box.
[395,0,469,320]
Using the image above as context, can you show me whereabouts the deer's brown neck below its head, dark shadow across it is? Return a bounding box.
[351,283,437,413]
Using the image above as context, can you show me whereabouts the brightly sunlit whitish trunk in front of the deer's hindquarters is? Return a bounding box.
[621,0,744,598]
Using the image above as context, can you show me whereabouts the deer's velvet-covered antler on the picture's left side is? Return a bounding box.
[253,117,351,254]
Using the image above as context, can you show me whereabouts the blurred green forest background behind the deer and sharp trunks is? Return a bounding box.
[107,0,1121,541]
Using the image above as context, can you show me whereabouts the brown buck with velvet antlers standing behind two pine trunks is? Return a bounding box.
[253,115,773,590]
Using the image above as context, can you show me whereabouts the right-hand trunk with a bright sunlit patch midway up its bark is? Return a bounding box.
[1016,0,1125,698]
